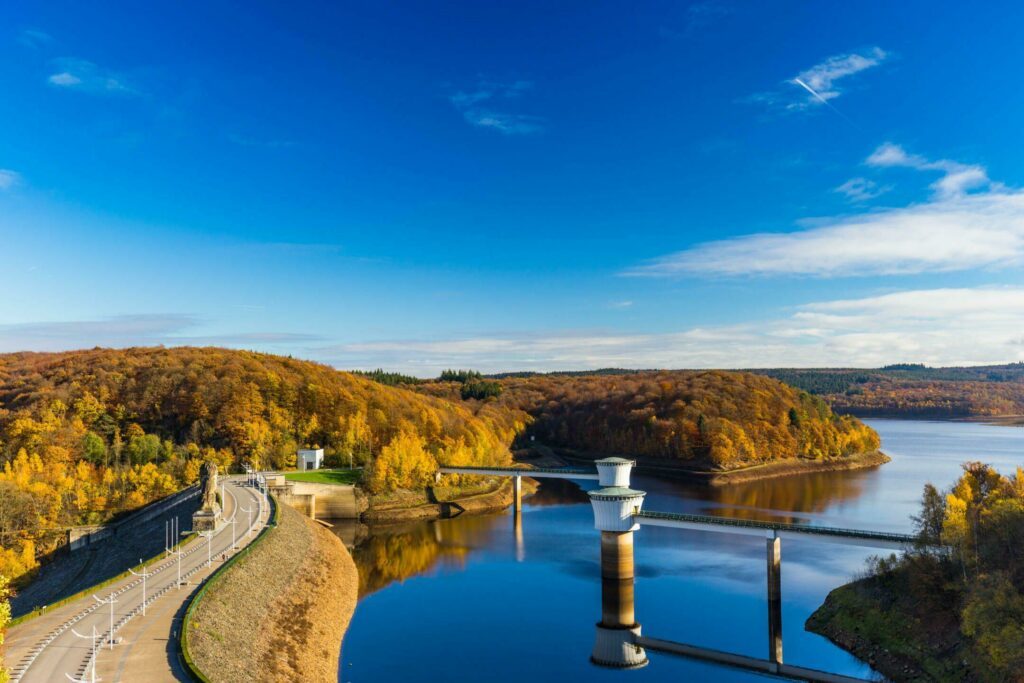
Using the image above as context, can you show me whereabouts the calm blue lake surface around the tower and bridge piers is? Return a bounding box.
[339,420,1024,683]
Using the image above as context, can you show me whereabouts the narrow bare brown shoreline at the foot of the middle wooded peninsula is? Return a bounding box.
[555,449,892,486]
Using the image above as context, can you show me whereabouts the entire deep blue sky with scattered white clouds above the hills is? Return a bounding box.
[0,0,1024,376]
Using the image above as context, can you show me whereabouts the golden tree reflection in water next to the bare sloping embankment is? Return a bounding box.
[352,515,508,598]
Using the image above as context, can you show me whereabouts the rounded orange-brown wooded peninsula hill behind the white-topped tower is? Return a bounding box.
[419,371,879,469]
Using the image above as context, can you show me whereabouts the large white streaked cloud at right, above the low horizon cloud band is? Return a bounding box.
[625,143,1024,278]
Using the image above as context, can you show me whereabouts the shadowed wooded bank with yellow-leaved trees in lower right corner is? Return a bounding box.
[808,462,1024,683]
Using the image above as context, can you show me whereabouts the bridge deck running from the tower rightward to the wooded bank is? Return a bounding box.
[634,510,918,548]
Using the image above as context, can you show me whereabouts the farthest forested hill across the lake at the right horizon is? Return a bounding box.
[752,362,1024,418]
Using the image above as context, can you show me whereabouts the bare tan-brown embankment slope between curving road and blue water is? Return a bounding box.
[188,499,358,683]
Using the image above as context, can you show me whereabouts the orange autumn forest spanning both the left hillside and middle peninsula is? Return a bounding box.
[0,347,879,580]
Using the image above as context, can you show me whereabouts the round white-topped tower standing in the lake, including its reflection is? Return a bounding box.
[589,458,647,669]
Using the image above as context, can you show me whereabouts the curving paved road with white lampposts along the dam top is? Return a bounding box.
[6,478,267,683]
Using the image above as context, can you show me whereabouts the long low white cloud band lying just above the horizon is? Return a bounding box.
[318,288,1024,377]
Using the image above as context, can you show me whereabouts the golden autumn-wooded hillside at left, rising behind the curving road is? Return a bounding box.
[0,348,526,579]
